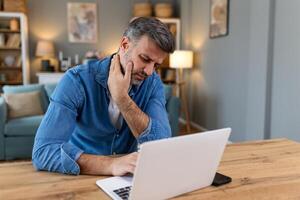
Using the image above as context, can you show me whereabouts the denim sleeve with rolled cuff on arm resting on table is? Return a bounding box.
[32,71,84,174]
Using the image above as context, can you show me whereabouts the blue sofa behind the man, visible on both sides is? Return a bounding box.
[0,84,180,160]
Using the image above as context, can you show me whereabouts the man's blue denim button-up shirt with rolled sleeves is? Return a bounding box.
[32,57,171,174]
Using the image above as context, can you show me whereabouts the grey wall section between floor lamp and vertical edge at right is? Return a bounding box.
[181,0,270,141]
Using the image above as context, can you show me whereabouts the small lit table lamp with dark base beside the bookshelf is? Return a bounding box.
[35,40,55,71]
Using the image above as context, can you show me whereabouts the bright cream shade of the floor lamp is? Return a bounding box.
[170,50,193,68]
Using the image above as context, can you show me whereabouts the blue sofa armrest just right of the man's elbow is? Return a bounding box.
[166,96,180,136]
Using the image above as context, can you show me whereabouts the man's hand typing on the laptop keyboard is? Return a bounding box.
[111,152,138,176]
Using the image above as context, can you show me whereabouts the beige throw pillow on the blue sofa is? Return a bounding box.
[4,91,44,119]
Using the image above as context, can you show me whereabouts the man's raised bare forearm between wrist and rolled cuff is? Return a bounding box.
[117,95,149,138]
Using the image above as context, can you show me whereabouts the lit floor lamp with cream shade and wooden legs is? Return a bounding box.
[170,50,193,132]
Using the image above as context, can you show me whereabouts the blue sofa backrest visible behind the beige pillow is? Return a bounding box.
[3,84,49,112]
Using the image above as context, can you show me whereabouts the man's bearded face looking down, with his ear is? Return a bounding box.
[119,35,167,85]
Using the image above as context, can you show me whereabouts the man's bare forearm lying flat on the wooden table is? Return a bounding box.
[77,154,113,175]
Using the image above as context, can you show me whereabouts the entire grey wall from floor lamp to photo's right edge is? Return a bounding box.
[181,0,300,141]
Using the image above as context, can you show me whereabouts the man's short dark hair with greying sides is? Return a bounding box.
[123,17,175,53]
